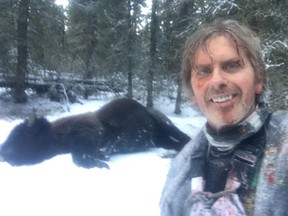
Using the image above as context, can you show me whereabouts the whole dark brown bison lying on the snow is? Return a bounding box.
[0,98,190,168]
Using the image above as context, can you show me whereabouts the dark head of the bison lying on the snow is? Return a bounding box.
[0,117,53,166]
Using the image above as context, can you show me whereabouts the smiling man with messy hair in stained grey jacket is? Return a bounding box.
[160,20,288,216]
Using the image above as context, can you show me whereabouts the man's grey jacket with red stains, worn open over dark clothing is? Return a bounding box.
[160,111,288,216]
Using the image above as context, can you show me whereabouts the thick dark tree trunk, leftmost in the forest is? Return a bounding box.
[13,0,30,103]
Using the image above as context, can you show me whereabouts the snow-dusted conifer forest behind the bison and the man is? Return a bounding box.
[0,0,288,113]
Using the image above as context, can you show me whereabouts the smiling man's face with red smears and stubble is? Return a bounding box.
[191,36,263,130]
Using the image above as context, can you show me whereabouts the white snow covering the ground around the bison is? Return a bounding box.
[0,97,205,216]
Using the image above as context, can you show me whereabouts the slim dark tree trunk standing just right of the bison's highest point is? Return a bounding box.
[147,0,158,108]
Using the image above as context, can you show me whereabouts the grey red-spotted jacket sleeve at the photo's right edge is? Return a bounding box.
[254,111,288,216]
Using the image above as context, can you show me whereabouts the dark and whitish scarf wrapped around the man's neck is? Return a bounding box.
[203,108,269,152]
